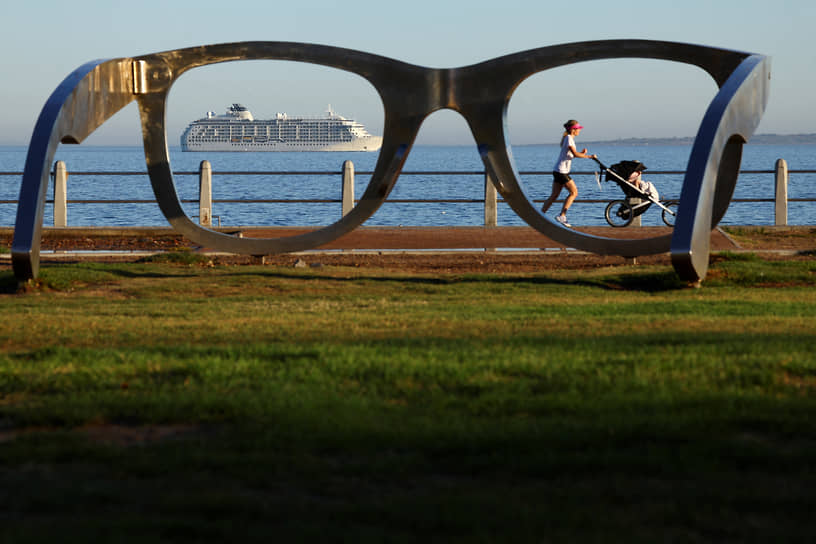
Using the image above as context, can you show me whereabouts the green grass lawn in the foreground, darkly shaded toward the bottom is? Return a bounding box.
[0,254,816,543]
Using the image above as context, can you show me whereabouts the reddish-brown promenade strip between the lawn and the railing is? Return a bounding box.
[0,227,816,274]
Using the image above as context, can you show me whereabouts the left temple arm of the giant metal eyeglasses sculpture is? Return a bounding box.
[11,59,135,282]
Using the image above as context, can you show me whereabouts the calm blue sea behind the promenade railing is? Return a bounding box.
[0,145,816,226]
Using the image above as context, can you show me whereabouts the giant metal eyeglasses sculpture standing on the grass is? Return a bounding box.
[12,40,770,282]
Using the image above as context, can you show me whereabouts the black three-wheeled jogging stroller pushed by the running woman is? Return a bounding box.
[594,159,677,227]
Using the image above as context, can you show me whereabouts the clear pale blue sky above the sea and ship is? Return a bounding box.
[0,0,816,145]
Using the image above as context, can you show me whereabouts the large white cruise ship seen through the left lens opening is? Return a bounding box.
[181,104,382,151]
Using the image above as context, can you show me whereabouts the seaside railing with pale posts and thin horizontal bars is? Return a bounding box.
[0,159,816,227]
